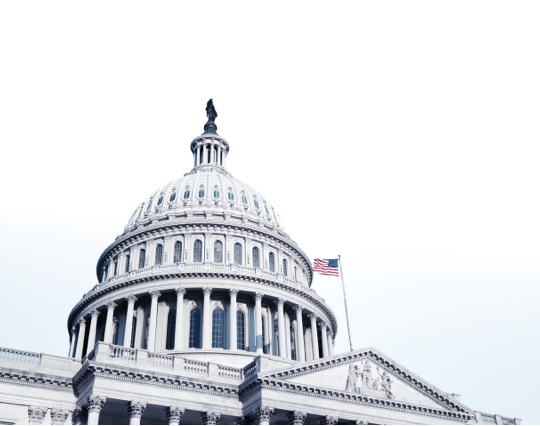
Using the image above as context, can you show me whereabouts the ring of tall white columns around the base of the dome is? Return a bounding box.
[69,286,333,362]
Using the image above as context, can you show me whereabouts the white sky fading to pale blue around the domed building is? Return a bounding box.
[0,1,540,423]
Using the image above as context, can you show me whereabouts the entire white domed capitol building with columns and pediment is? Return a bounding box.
[0,100,520,425]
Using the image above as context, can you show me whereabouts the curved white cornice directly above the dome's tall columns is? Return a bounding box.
[68,272,337,335]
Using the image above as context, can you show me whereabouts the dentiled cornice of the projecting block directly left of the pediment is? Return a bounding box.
[73,361,238,399]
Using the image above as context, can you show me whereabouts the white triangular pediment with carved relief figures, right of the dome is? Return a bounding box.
[259,348,471,413]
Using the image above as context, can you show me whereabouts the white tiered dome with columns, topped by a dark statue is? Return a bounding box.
[68,102,337,365]
